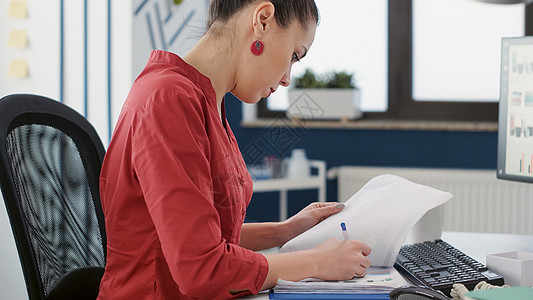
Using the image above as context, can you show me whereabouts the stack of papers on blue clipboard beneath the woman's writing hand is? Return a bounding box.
[274,267,407,294]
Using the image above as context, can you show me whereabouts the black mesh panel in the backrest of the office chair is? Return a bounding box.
[7,124,105,296]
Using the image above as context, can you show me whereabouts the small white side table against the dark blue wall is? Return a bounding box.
[254,160,326,221]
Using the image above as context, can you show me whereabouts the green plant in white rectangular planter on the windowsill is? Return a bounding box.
[287,69,363,120]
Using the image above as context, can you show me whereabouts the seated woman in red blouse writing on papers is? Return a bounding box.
[99,0,370,299]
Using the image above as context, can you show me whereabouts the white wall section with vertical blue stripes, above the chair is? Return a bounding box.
[0,0,132,145]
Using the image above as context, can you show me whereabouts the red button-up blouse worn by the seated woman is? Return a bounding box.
[98,51,268,300]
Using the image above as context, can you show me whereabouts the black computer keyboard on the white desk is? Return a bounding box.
[394,240,504,296]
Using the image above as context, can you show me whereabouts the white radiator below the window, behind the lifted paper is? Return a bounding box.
[328,166,533,234]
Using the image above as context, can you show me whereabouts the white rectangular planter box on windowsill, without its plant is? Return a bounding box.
[287,89,363,120]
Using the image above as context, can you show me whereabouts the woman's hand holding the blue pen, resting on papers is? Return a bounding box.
[310,238,371,280]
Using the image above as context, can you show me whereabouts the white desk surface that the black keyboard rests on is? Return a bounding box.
[242,231,533,300]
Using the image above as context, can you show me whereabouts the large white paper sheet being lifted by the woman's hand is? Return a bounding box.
[280,174,453,267]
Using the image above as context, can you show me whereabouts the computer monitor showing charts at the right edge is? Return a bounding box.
[497,37,533,182]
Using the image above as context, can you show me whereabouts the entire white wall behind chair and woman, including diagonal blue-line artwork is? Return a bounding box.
[0,0,210,299]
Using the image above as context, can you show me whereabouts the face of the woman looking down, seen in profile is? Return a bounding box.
[231,21,316,103]
